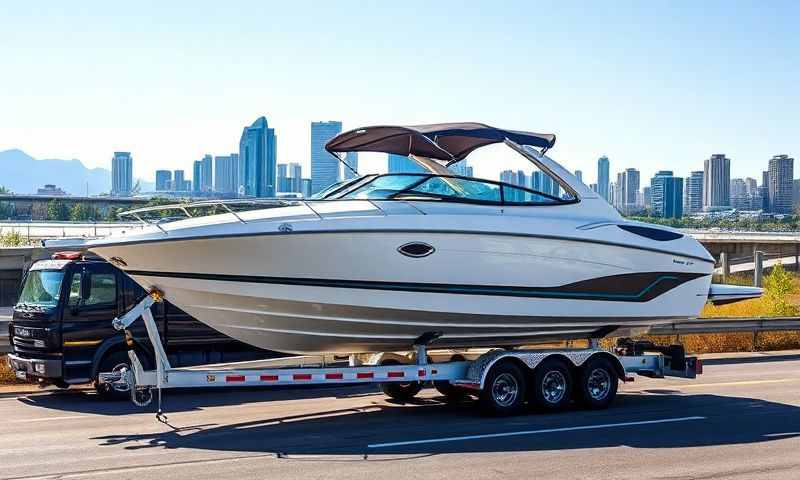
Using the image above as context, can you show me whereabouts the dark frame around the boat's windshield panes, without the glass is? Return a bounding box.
[314,172,580,206]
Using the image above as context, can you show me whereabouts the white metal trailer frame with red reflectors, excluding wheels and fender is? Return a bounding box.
[99,289,702,421]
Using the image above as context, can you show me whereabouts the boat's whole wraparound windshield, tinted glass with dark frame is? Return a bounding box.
[321,173,576,205]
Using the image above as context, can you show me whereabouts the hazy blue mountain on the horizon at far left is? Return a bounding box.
[0,149,153,195]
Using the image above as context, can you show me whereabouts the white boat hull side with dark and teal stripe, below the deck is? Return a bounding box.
[93,223,713,353]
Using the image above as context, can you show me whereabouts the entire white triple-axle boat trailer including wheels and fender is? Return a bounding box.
[100,290,702,420]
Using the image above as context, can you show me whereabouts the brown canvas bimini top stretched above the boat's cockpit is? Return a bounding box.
[325,123,556,162]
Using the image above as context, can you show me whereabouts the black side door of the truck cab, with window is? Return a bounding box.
[61,263,119,383]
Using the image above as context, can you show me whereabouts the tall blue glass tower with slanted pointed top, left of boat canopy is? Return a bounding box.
[237,117,278,197]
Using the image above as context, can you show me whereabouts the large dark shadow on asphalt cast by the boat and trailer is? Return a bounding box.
[83,391,800,457]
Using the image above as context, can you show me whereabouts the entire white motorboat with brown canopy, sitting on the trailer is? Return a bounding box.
[86,123,760,354]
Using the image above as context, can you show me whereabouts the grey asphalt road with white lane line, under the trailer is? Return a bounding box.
[0,352,800,480]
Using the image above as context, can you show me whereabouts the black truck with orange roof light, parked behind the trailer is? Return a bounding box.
[8,252,277,397]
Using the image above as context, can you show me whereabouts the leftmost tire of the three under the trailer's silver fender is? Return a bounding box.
[479,361,527,416]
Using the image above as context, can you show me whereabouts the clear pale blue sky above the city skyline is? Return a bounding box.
[0,0,800,183]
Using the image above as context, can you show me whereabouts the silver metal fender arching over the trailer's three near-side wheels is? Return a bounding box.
[467,350,626,390]
